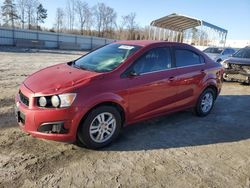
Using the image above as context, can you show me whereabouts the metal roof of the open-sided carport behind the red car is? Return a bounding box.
[150,13,227,33]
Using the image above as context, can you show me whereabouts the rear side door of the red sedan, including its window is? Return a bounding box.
[173,47,206,108]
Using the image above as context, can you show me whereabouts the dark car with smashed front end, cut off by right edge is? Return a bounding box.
[222,46,250,84]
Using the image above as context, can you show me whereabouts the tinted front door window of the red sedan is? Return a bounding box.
[133,48,171,74]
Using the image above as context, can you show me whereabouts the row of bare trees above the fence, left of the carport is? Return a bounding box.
[1,0,148,40]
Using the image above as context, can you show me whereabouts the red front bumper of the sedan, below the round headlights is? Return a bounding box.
[15,85,85,142]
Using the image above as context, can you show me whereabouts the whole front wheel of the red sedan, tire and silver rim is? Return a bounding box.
[77,106,122,149]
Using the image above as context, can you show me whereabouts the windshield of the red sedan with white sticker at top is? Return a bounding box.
[74,44,140,72]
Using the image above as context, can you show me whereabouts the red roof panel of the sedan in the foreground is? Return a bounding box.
[115,40,189,47]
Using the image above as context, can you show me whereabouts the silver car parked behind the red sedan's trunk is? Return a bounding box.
[203,47,236,63]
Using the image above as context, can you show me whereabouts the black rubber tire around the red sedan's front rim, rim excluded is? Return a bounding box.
[77,106,122,149]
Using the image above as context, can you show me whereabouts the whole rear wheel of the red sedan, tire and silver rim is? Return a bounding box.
[194,88,216,117]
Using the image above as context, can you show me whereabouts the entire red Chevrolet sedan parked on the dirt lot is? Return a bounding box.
[16,41,223,148]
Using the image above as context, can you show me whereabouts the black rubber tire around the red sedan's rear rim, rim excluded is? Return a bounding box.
[194,88,216,117]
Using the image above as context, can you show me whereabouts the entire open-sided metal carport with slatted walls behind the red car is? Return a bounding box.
[149,13,227,46]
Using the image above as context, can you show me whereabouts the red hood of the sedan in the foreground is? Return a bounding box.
[24,63,100,94]
